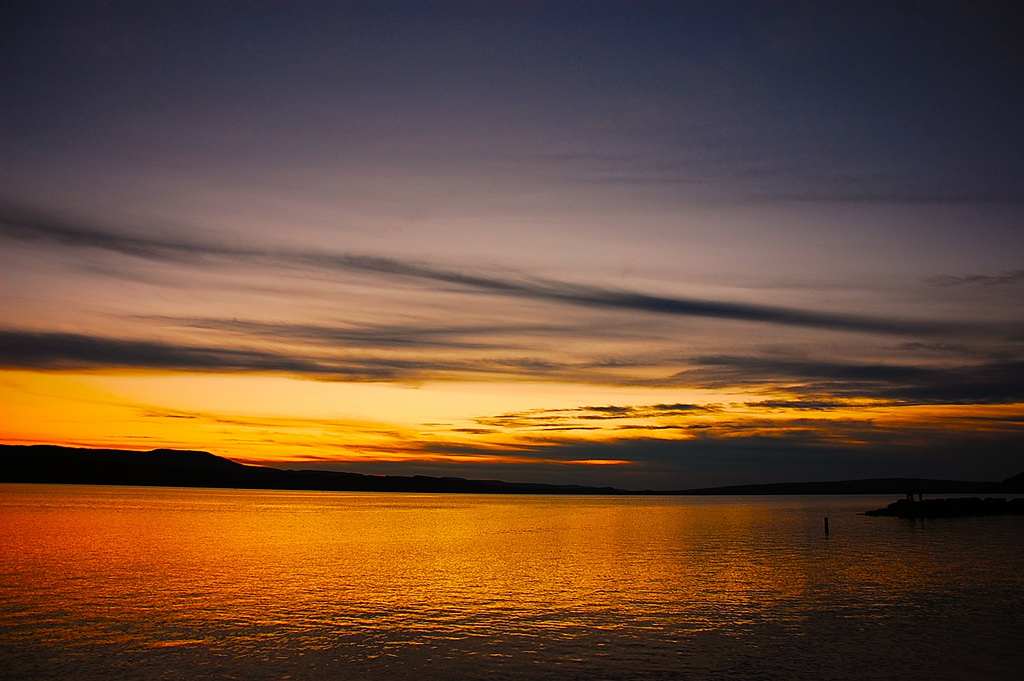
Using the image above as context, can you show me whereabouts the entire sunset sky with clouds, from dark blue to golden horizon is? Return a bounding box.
[0,1,1024,488]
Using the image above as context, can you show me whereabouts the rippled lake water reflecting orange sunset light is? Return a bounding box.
[0,484,1024,681]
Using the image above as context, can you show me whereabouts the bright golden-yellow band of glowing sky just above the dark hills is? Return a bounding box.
[0,372,1024,467]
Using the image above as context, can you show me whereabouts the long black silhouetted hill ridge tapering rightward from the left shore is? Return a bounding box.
[0,444,625,495]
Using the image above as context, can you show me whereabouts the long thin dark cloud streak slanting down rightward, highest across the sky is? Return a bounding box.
[0,208,966,335]
